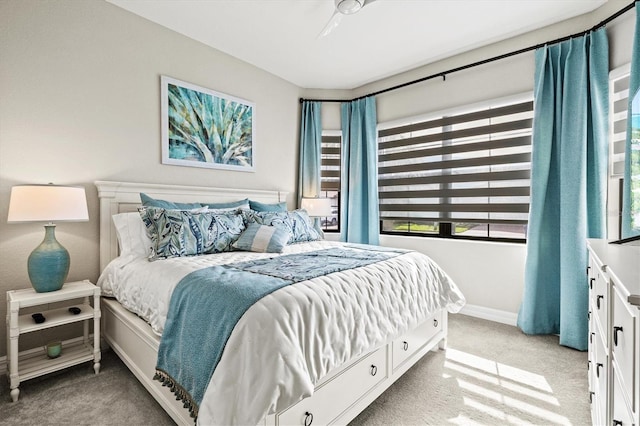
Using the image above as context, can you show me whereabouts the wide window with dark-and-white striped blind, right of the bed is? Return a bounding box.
[378,94,533,241]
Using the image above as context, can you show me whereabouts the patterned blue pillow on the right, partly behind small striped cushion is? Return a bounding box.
[243,210,322,244]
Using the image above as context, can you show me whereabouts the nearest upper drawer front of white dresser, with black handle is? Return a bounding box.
[610,286,638,412]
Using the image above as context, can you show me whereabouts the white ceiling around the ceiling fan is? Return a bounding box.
[107,0,607,89]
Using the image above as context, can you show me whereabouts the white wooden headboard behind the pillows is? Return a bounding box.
[95,181,288,271]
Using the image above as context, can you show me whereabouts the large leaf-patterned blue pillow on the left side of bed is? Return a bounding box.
[139,207,245,260]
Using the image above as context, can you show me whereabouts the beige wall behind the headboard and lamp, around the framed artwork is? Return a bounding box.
[0,0,300,356]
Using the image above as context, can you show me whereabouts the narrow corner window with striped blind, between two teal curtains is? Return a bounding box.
[320,131,342,232]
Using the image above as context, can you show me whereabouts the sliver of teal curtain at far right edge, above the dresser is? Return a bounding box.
[621,7,640,238]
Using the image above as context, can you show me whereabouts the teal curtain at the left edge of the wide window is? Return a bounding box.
[340,96,380,245]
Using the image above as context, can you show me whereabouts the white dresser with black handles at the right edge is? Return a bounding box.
[587,239,640,426]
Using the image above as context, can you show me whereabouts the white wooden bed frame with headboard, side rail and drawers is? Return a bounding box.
[95,181,447,426]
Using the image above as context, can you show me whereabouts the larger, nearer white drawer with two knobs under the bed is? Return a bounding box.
[277,346,388,425]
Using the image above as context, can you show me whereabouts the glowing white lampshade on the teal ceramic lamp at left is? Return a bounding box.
[7,184,89,222]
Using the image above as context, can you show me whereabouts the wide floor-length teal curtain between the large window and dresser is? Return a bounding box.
[518,28,609,350]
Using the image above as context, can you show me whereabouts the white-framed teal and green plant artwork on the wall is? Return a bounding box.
[160,76,255,172]
